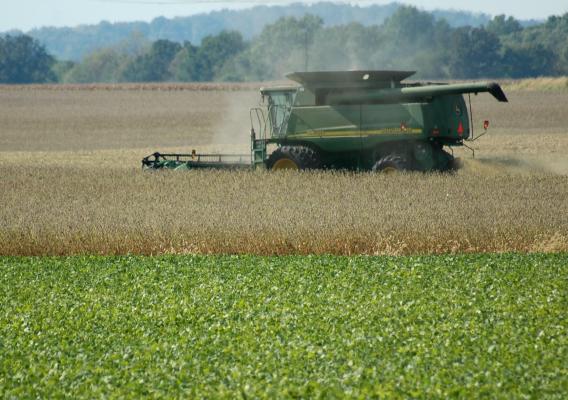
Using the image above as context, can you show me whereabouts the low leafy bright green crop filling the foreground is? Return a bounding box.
[0,254,568,399]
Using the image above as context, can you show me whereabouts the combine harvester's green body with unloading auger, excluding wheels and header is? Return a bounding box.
[261,71,506,169]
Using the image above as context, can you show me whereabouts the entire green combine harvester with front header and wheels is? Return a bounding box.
[142,71,507,172]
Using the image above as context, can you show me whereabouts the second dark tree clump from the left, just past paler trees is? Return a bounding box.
[122,40,182,82]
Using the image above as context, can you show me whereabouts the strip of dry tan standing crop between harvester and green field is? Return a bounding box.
[0,167,568,255]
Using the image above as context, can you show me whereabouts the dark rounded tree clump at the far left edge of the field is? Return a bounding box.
[0,35,56,83]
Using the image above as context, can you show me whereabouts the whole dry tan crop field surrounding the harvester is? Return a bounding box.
[0,85,568,255]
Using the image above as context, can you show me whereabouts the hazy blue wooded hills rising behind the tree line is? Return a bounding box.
[24,2,490,62]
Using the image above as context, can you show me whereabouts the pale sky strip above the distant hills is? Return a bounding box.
[0,0,568,32]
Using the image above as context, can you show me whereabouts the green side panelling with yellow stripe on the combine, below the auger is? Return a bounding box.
[270,95,470,169]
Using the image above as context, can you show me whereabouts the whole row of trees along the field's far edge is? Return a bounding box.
[0,6,568,83]
